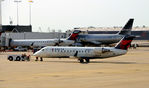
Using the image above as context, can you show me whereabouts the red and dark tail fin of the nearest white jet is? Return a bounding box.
[115,36,135,50]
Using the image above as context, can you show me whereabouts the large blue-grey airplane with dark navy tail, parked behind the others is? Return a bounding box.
[74,19,134,46]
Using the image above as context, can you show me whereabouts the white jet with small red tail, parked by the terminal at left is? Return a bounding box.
[10,30,81,47]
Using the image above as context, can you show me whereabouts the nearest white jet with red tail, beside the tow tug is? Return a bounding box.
[34,36,135,63]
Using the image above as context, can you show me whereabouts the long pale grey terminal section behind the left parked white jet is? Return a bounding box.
[0,32,66,47]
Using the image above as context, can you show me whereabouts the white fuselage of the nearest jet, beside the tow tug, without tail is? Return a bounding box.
[34,46,127,59]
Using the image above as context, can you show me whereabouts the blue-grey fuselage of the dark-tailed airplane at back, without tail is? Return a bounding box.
[77,34,125,45]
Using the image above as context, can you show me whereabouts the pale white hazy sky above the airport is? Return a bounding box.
[1,0,149,32]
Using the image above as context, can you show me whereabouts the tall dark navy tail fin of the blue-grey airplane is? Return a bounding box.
[118,19,134,35]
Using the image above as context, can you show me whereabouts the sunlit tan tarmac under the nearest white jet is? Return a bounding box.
[0,47,149,88]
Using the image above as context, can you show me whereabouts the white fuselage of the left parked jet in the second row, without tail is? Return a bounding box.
[10,39,74,47]
